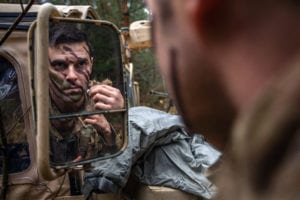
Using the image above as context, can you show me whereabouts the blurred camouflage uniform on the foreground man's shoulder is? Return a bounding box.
[219,60,300,200]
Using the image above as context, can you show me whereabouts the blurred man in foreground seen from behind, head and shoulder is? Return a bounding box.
[146,0,300,199]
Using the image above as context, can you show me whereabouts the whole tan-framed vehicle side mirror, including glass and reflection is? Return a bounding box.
[31,6,128,180]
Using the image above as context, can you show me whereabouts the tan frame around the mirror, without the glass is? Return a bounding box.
[29,3,128,180]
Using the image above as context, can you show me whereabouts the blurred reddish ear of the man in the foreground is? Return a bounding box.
[185,0,227,39]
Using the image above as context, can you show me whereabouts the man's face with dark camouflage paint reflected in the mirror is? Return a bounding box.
[49,42,93,102]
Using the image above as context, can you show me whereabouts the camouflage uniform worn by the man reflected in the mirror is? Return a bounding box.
[50,94,116,162]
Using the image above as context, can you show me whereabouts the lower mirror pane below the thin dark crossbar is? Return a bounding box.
[50,113,124,163]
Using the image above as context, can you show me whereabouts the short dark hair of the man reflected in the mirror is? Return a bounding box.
[49,23,93,57]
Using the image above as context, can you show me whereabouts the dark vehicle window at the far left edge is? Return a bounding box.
[0,55,30,174]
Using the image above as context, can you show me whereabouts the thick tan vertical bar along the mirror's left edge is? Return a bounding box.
[34,3,64,181]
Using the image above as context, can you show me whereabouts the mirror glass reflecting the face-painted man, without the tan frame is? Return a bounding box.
[48,20,126,165]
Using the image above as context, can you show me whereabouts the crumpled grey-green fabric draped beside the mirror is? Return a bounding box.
[82,107,221,199]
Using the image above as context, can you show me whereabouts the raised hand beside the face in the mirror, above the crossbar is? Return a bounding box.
[89,84,124,110]
